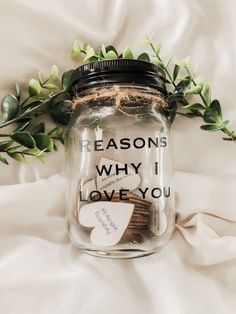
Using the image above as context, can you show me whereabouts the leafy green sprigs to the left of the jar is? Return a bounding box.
[0,65,72,164]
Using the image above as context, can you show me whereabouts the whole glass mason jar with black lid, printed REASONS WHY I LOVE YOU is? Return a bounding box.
[66,59,174,258]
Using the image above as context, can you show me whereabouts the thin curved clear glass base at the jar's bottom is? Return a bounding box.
[81,249,159,259]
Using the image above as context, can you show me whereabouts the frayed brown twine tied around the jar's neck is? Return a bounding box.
[72,85,167,109]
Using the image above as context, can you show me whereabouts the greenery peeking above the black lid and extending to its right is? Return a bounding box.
[71,37,236,141]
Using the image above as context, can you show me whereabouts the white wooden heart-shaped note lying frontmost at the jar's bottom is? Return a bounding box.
[79,202,134,246]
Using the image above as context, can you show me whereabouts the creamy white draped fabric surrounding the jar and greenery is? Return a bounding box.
[0,0,236,314]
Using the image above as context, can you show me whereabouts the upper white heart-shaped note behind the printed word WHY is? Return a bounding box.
[97,157,141,192]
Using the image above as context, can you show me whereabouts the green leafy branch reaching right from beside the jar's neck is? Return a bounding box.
[141,38,236,141]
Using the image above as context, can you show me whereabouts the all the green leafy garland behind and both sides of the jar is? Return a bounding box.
[0,37,236,164]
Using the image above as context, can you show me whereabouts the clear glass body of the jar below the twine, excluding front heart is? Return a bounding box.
[66,86,174,256]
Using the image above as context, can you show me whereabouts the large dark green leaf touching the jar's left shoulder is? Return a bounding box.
[49,100,72,125]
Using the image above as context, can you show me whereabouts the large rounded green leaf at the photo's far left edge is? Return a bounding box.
[1,95,20,122]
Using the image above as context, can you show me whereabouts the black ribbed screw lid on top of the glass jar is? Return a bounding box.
[71,59,167,95]
